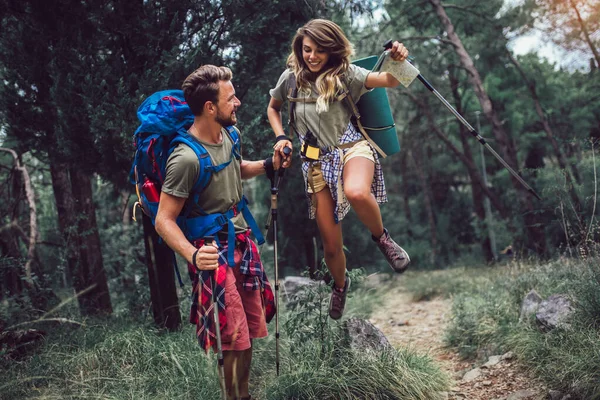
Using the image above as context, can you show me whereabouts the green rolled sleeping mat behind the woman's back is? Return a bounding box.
[352,56,400,157]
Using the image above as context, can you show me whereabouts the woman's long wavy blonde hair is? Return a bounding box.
[287,19,354,113]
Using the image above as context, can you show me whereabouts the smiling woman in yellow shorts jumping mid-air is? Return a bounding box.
[267,19,410,319]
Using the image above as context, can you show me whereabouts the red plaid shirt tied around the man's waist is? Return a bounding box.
[188,231,276,352]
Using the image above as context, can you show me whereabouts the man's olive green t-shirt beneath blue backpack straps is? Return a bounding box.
[162,128,248,233]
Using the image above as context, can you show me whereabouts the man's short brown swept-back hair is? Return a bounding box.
[181,64,231,115]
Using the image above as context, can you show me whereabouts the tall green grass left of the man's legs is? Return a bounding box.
[0,320,219,400]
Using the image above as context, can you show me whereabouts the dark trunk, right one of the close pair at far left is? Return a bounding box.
[69,167,112,316]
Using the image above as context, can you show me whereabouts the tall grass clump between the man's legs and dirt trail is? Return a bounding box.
[253,270,449,400]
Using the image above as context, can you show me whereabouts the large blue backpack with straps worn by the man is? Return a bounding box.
[129,90,265,274]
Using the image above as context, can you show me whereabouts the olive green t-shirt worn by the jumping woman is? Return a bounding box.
[269,64,371,147]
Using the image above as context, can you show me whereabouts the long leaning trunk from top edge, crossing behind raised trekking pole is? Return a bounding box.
[429,0,547,256]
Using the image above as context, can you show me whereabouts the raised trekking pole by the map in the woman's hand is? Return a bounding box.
[382,40,542,200]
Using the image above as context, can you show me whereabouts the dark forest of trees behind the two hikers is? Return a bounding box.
[0,0,600,396]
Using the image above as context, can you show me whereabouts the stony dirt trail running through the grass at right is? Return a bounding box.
[370,279,548,400]
